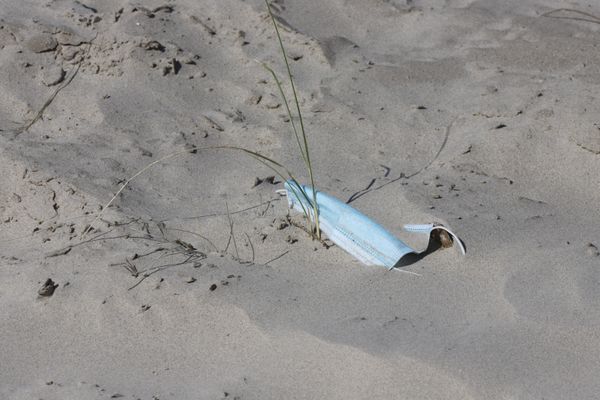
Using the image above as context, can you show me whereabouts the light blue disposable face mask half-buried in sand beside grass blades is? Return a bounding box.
[284,180,466,269]
